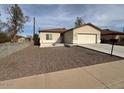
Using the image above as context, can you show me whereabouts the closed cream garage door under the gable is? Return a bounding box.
[78,34,96,44]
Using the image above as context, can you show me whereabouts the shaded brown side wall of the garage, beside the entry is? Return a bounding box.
[64,30,73,43]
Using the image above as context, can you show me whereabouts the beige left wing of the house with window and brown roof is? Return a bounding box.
[39,28,66,47]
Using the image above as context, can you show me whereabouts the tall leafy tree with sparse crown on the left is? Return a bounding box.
[7,4,28,42]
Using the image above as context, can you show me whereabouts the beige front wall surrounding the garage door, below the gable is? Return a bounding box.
[73,25,101,44]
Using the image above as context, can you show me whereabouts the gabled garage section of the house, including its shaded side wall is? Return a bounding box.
[64,23,101,44]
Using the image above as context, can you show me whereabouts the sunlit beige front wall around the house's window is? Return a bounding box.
[39,32,61,47]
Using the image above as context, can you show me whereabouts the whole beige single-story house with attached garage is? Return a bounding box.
[39,23,102,47]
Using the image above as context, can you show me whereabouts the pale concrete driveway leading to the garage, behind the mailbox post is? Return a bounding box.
[78,44,124,57]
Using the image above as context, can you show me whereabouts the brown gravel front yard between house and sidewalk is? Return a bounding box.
[0,46,122,81]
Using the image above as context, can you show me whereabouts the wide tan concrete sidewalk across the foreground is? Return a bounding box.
[0,60,124,88]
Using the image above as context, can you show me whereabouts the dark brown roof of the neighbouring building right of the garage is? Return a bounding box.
[101,29,124,35]
